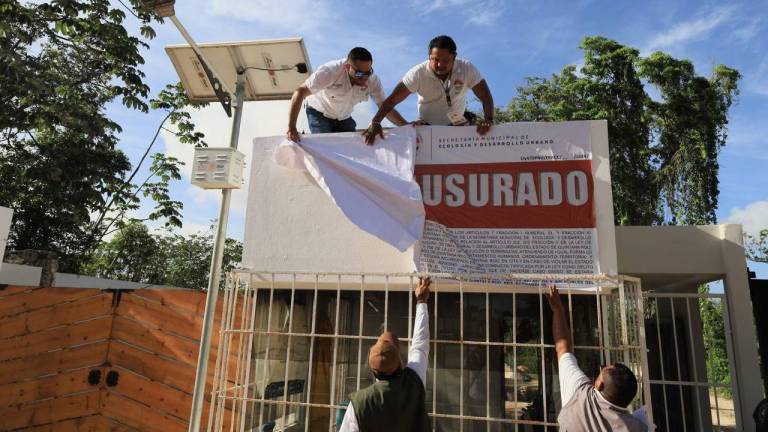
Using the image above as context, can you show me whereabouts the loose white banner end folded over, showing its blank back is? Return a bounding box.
[272,126,424,252]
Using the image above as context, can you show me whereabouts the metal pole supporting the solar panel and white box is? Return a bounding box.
[189,72,245,432]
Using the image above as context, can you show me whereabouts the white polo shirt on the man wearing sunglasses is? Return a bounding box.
[304,59,384,120]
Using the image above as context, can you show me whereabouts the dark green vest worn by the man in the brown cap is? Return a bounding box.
[350,367,431,432]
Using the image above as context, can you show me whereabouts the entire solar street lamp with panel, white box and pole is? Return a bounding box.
[141,0,310,432]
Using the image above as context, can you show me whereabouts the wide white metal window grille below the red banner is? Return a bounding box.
[208,271,651,431]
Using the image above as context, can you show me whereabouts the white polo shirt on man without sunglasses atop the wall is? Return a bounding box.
[402,58,483,125]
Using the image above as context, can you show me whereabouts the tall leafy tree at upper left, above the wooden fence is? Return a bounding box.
[0,0,207,272]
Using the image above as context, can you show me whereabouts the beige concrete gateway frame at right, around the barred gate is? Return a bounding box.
[616,224,763,430]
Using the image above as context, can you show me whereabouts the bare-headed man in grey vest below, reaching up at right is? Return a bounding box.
[547,285,648,432]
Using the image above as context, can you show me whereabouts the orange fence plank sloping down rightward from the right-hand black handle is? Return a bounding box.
[109,368,192,421]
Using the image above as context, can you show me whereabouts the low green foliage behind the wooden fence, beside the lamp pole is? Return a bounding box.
[84,221,243,289]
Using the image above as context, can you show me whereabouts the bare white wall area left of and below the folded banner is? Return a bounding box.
[243,137,413,272]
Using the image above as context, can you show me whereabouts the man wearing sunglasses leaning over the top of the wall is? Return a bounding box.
[286,47,407,142]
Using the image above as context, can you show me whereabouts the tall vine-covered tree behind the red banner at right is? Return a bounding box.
[497,36,740,225]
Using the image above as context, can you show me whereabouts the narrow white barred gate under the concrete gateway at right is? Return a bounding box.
[643,292,740,432]
